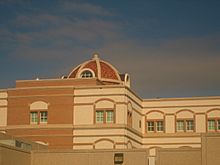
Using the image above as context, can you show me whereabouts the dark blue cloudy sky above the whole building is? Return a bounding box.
[0,0,220,98]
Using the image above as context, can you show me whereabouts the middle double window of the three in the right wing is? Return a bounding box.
[176,119,194,132]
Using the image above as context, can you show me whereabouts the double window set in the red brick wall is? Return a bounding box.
[30,111,48,124]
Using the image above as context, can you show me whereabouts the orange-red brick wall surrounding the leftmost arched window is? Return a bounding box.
[7,85,74,148]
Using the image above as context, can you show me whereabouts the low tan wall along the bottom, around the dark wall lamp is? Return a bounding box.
[32,149,148,165]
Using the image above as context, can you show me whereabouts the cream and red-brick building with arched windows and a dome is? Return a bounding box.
[0,55,220,164]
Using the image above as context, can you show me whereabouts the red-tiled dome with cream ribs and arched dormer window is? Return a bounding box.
[68,54,122,83]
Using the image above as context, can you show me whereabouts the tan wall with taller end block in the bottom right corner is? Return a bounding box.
[156,133,220,165]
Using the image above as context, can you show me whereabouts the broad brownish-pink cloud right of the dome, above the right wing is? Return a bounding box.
[97,36,220,97]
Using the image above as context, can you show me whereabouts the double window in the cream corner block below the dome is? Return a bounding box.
[95,110,114,124]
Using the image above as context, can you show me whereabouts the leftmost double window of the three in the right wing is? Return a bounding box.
[146,120,164,132]
